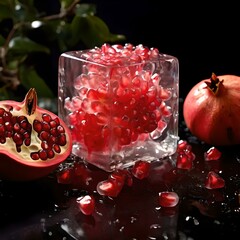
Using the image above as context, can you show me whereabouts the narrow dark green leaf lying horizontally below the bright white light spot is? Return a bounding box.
[9,36,50,54]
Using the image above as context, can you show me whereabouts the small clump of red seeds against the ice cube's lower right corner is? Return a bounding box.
[176,140,196,170]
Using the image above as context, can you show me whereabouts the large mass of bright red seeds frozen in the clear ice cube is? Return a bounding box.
[65,44,172,153]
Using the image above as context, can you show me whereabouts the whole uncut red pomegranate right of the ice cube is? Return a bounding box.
[183,73,240,146]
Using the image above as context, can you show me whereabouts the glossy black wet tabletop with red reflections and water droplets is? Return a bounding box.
[0,103,240,240]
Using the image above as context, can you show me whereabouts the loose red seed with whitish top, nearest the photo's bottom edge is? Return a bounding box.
[77,195,95,215]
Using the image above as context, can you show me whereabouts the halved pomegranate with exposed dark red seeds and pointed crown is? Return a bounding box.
[0,88,72,181]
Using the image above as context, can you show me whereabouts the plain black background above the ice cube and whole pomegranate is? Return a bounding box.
[82,0,240,97]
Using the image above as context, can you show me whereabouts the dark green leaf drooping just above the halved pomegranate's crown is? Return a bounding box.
[19,65,54,98]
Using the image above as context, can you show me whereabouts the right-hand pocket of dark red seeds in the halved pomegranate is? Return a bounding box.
[31,114,67,160]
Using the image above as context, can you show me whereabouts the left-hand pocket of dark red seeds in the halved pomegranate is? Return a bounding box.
[0,108,32,152]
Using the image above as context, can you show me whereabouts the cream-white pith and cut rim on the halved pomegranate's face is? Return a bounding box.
[0,89,71,164]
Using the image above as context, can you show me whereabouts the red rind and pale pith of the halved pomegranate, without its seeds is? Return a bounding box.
[0,91,72,181]
